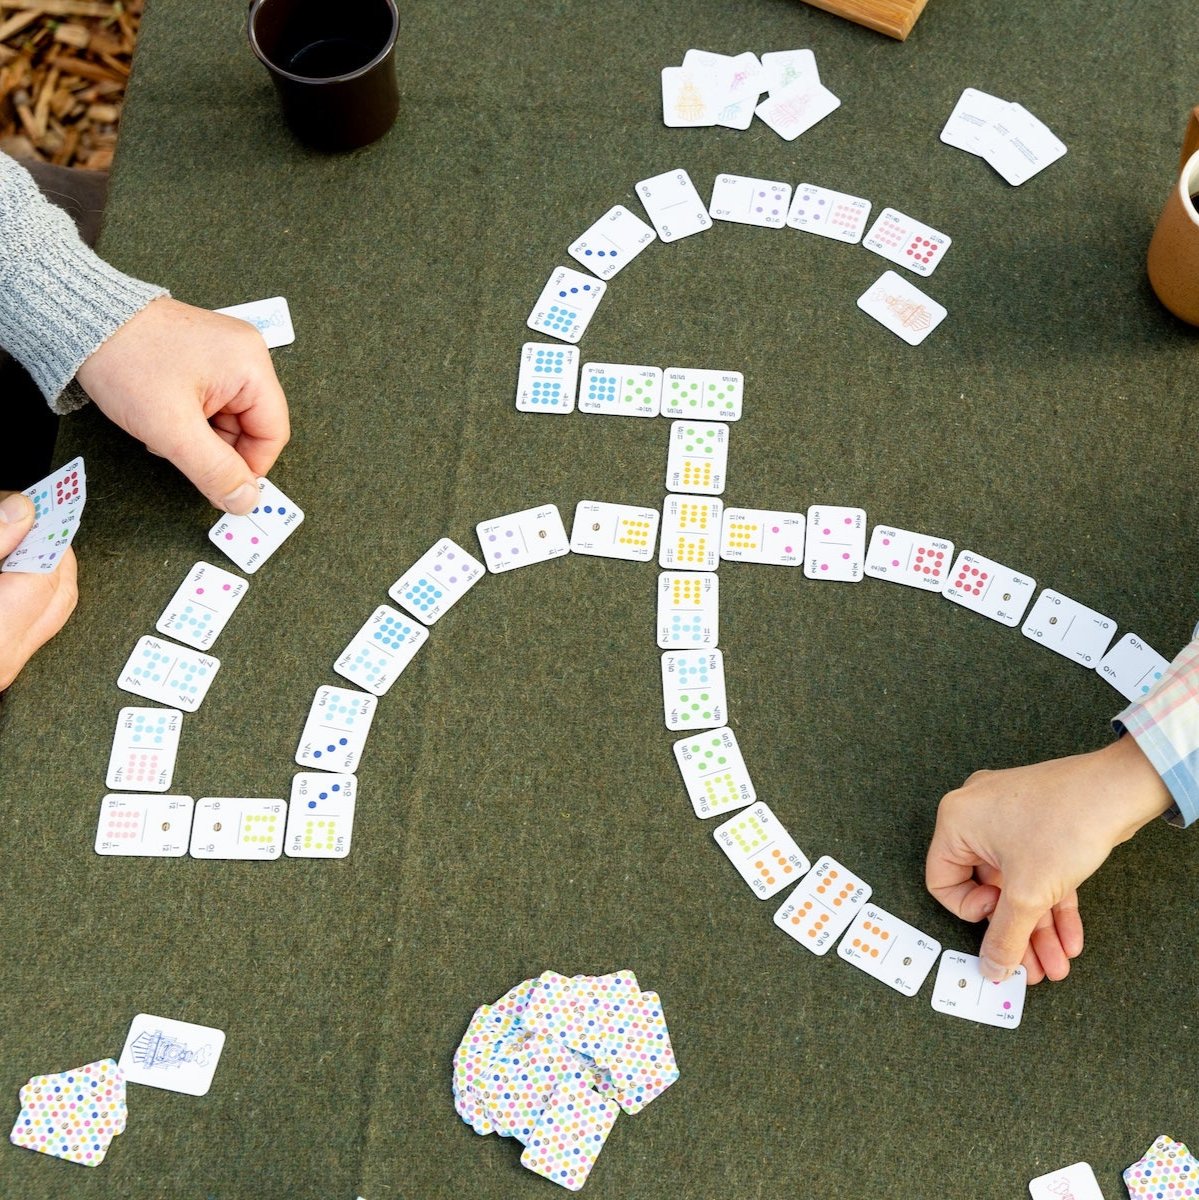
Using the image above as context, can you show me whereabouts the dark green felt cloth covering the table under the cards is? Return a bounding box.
[0,0,1199,1200]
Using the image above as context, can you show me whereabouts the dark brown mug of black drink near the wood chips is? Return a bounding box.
[248,0,400,150]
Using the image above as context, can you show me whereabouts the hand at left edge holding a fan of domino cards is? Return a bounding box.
[0,492,79,691]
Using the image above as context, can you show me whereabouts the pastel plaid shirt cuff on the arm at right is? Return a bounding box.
[1111,625,1199,826]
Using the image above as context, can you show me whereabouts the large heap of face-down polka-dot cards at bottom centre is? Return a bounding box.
[452,971,678,1192]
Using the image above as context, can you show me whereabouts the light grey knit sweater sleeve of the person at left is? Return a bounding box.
[0,154,167,413]
